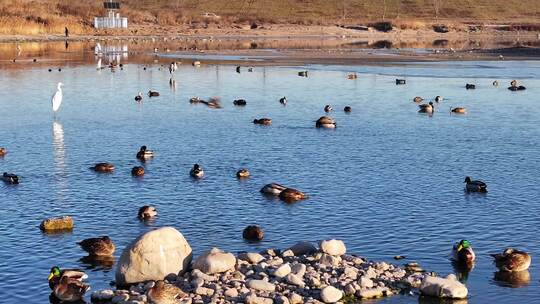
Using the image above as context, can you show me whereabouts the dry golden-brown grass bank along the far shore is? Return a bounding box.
[0,0,540,35]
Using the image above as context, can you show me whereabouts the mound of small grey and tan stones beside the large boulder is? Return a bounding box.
[91,228,467,304]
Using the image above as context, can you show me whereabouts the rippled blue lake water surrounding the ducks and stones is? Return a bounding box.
[0,44,540,303]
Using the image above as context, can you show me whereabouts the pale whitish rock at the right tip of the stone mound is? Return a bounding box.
[420,274,469,299]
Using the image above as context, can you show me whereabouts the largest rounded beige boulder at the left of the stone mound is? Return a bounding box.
[116,227,192,286]
